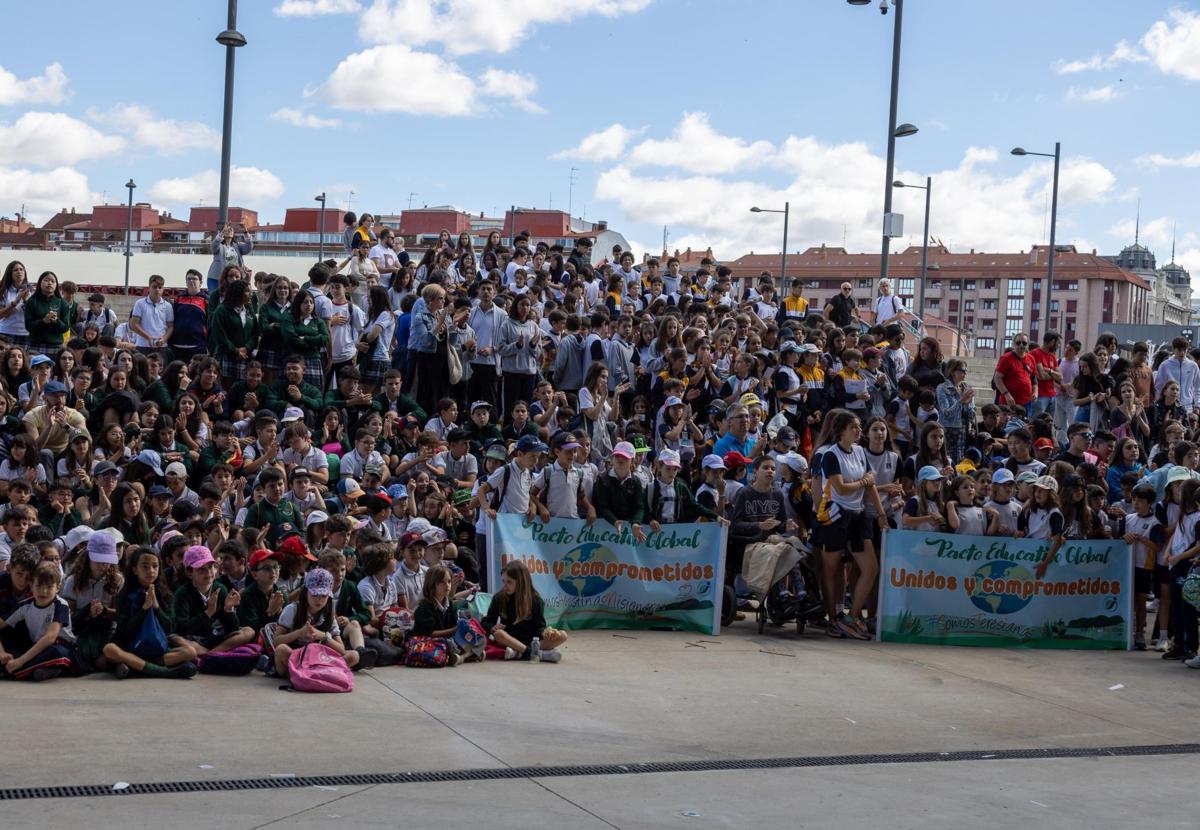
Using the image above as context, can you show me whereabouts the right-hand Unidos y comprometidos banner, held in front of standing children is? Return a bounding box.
[878,530,1133,649]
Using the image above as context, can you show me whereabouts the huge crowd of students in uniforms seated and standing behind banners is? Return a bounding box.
[0,217,1200,679]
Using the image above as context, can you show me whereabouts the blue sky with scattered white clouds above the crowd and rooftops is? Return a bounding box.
[0,0,1200,278]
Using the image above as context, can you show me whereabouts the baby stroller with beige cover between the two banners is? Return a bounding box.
[742,535,823,634]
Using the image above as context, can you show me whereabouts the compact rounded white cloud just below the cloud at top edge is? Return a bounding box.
[318,44,475,115]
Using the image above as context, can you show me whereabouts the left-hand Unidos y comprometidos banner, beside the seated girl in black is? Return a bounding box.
[487,513,726,634]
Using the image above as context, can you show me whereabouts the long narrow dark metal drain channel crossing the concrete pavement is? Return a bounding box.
[0,744,1200,801]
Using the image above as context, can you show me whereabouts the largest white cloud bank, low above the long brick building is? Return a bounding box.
[585,114,1115,258]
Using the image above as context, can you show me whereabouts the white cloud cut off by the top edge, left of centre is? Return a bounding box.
[359,0,650,55]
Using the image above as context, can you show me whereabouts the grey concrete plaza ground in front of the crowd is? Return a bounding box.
[0,621,1200,830]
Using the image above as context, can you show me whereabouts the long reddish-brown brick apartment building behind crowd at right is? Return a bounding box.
[726,245,1152,354]
